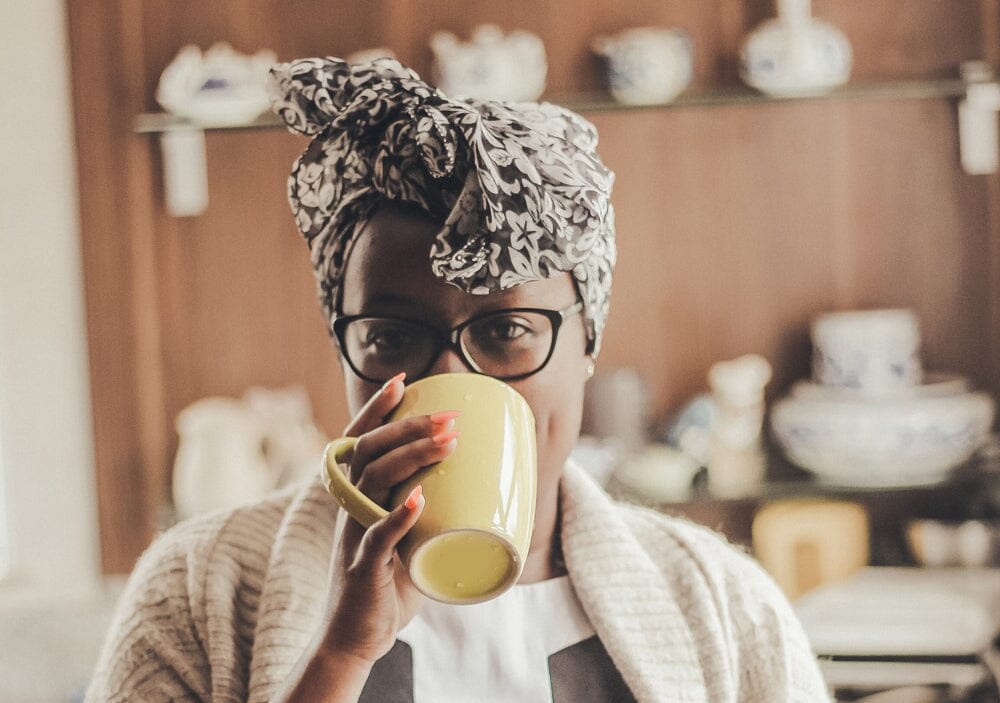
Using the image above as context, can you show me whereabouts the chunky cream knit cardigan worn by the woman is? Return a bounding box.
[87,465,829,703]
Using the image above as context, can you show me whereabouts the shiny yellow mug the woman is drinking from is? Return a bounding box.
[322,373,537,603]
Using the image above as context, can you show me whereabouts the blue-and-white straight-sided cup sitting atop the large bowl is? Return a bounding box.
[811,310,923,395]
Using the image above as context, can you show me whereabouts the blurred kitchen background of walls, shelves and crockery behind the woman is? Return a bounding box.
[0,0,1000,701]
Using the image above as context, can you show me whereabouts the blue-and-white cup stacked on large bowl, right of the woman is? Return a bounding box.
[771,310,995,487]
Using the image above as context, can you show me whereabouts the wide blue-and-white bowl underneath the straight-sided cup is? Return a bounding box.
[771,392,995,488]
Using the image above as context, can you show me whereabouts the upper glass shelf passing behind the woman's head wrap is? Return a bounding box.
[133,78,967,134]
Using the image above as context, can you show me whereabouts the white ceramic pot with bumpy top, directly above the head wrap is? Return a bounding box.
[430,24,548,102]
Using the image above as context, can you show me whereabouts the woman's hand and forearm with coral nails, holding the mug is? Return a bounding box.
[278,375,458,701]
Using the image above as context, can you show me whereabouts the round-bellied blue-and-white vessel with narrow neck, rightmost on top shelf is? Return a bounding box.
[740,0,852,97]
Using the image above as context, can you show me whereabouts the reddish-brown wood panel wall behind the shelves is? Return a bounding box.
[68,0,1000,572]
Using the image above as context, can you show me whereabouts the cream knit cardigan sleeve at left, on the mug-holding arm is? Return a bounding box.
[86,520,226,703]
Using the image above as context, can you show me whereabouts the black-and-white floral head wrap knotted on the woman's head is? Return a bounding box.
[268,58,616,353]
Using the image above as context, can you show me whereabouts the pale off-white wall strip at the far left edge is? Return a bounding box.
[0,0,99,605]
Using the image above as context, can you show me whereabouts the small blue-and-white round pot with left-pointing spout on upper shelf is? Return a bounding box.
[591,27,694,105]
